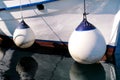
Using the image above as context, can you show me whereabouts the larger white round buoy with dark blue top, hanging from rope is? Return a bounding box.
[68,18,106,64]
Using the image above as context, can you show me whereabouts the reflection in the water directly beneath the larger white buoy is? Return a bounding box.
[70,62,106,80]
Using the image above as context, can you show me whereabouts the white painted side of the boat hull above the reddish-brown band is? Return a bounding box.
[0,0,119,45]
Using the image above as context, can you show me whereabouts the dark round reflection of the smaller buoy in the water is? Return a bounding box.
[16,57,38,80]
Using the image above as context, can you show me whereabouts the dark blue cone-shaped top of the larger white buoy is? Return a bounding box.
[76,18,96,31]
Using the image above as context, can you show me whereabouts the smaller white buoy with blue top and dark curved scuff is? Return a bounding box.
[13,20,35,48]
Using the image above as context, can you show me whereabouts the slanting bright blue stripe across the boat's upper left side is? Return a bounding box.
[0,0,59,11]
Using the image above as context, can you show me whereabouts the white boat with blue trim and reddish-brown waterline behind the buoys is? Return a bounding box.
[0,0,120,62]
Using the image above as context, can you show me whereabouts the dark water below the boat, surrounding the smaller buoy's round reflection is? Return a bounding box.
[0,45,115,80]
